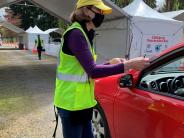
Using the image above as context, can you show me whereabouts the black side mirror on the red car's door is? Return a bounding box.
[119,74,133,88]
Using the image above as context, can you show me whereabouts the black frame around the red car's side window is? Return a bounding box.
[135,44,184,100]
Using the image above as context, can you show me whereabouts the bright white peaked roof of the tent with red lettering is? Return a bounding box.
[123,0,178,21]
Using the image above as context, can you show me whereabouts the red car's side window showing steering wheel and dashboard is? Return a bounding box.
[139,57,184,98]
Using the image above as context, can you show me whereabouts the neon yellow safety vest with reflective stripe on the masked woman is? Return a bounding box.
[54,22,97,111]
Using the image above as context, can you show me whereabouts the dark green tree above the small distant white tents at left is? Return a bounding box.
[9,0,58,30]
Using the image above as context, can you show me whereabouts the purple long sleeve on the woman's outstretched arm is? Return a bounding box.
[64,29,124,78]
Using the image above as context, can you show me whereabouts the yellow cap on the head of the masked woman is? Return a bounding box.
[77,0,112,14]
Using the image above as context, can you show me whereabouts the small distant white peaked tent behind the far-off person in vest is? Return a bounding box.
[26,26,49,50]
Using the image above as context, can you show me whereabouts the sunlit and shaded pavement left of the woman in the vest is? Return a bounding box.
[0,50,61,138]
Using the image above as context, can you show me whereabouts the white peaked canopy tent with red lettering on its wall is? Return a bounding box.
[122,0,184,58]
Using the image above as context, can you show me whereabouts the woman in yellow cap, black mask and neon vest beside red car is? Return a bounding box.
[54,0,148,138]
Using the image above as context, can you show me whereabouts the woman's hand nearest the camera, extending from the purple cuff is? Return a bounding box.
[124,57,150,72]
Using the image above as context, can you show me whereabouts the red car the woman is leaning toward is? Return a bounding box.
[92,43,184,138]
